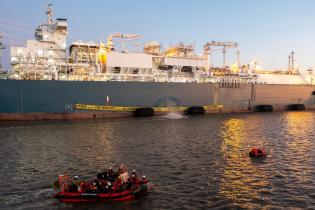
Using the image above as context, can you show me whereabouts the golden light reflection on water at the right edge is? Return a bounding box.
[282,112,315,199]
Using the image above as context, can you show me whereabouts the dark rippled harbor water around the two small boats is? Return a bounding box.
[0,112,315,210]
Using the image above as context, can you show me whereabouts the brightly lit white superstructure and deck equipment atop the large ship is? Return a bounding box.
[6,5,315,84]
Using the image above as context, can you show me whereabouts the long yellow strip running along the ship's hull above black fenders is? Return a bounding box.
[74,104,223,112]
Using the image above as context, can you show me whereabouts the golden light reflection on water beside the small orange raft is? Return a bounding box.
[218,119,269,208]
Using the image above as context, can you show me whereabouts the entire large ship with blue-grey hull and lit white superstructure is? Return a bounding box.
[0,5,315,120]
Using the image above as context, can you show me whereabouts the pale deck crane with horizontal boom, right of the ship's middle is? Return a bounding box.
[204,41,239,70]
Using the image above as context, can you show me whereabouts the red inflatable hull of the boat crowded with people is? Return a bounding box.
[53,183,153,203]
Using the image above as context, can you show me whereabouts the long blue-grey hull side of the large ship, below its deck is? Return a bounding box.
[0,80,315,120]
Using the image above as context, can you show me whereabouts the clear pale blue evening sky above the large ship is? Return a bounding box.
[0,0,315,70]
